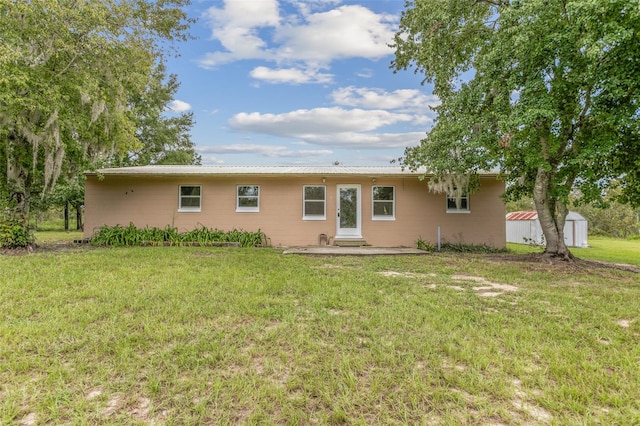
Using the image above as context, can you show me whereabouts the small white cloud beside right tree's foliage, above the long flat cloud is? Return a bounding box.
[331,86,440,115]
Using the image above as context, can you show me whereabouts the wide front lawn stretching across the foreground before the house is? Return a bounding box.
[0,247,640,425]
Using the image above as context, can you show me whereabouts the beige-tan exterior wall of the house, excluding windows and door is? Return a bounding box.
[85,175,506,247]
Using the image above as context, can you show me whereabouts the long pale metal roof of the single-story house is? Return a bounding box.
[87,166,497,177]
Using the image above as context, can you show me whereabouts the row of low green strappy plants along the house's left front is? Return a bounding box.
[90,223,266,247]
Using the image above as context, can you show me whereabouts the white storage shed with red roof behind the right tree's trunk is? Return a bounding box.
[506,211,588,247]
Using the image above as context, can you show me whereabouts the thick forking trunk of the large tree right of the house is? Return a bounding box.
[533,168,574,260]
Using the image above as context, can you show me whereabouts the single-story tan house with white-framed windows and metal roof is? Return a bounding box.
[84,166,505,247]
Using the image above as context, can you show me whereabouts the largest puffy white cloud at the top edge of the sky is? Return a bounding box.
[199,0,397,76]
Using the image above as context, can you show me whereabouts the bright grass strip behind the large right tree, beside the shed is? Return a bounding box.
[507,237,640,266]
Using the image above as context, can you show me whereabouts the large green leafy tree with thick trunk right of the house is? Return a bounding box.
[392,0,640,259]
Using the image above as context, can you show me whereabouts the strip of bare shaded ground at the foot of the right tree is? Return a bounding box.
[484,253,640,274]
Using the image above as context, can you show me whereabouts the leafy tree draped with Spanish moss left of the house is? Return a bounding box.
[0,0,189,223]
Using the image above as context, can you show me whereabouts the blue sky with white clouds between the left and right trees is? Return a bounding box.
[168,0,438,166]
